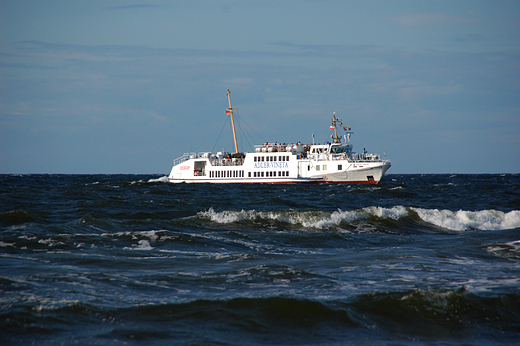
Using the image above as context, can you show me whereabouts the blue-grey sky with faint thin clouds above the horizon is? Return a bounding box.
[0,0,520,175]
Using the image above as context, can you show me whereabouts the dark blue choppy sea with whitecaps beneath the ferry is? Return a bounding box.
[0,174,520,345]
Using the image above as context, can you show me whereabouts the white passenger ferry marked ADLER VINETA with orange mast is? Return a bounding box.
[168,90,390,184]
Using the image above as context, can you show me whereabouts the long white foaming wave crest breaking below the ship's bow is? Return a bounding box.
[197,206,520,231]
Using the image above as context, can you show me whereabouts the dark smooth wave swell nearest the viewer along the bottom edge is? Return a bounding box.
[0,288,520,345]
